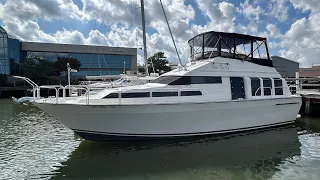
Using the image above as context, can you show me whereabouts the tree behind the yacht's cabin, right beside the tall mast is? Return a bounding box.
[138,52,172,74]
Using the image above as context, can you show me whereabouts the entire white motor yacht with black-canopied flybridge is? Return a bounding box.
[33,31,301,140]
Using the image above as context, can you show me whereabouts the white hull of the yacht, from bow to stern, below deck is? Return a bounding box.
[34,97,301,140]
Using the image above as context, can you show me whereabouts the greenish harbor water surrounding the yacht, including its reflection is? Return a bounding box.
[0,99,320,180]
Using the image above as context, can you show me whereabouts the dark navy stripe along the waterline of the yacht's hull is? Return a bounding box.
[72,121,294,140]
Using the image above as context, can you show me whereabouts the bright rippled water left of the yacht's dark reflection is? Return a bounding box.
[0,102,80,180]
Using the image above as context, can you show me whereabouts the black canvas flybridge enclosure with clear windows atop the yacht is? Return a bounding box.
[188,31,273,67]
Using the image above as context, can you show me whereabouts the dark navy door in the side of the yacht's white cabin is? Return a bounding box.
[230,77,245,99]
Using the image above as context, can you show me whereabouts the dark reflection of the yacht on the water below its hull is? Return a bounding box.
[53,126,301,179]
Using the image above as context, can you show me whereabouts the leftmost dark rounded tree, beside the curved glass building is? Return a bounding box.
[21,55,55,83]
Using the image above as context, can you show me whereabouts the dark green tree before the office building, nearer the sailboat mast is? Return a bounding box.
[54,57,81,75]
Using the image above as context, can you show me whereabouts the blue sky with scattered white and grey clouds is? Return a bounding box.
[0,0,320,67]
